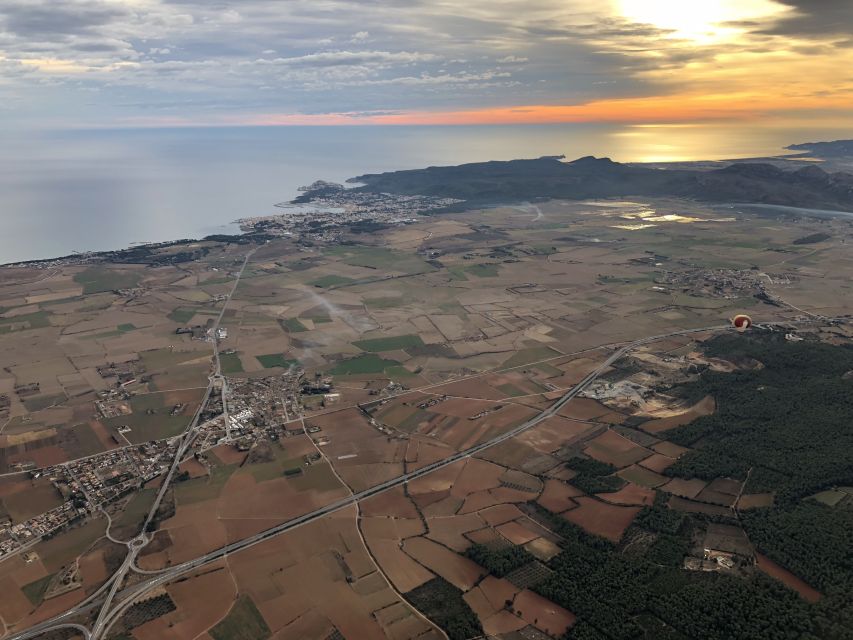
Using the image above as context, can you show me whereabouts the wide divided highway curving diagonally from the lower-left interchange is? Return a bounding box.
[1,325,731,640]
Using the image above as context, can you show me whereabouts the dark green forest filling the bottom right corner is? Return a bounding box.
[534,508,853,640]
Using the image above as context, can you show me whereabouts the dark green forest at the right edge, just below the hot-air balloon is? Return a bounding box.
[666,332,853,504]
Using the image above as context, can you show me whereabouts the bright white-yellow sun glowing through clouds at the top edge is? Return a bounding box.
[618,0,786,43]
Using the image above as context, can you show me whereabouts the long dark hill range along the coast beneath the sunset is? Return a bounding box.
[344,156,853,211]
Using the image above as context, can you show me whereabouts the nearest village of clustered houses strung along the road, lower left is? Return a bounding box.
[0,365,337,560]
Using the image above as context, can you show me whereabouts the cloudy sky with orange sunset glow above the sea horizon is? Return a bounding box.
[0,0,853,131]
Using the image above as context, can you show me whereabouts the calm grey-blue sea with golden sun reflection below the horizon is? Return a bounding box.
[0,124,844,264]
